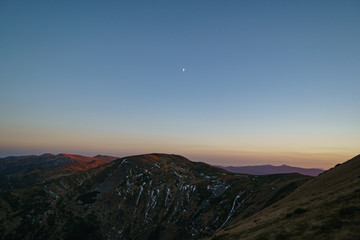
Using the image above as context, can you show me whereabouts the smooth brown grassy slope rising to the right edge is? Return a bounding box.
[211,155,360,240]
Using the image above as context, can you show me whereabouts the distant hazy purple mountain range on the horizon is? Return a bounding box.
[216,165,324,176]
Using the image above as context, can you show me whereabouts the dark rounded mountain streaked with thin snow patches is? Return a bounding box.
[0,154,311,239]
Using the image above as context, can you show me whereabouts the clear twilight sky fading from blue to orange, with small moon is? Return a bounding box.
[0,0,360,168]
